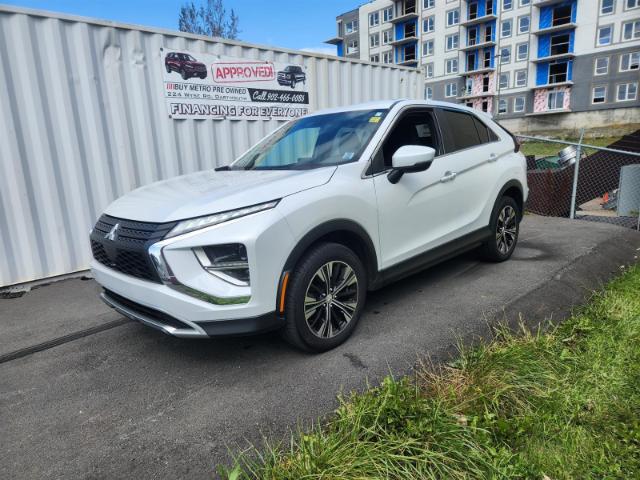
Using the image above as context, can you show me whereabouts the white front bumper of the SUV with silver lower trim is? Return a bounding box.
[91,206,293,337]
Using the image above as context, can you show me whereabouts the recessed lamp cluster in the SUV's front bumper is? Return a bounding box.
[193,243,250,286]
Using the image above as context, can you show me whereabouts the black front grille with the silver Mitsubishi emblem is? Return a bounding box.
[91,215,175,283]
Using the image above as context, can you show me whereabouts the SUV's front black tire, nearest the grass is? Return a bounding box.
[282,243,367,352]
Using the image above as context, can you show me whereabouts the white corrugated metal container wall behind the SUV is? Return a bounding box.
[0,6,422,287]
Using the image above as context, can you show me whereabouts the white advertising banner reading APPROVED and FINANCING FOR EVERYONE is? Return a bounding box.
[161,48,309,120]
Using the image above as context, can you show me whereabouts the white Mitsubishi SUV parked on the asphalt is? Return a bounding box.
[91,100,527,351]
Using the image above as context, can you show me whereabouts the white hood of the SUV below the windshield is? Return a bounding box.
[104,166,337,223]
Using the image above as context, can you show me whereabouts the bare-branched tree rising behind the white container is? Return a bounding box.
[178,0,240,39]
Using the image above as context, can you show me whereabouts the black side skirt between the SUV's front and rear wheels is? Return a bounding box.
[369,226,491,290]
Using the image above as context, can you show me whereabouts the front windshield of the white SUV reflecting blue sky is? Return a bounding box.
[230,109,388,170]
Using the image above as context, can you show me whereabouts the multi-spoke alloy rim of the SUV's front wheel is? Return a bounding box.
[304,261,358,338]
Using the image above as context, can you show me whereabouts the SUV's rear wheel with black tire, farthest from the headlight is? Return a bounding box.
[480,197,522,262]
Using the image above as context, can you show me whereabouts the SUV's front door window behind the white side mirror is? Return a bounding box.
[381,111,438,169]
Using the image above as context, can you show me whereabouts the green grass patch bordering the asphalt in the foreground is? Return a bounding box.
[219,267,640,480]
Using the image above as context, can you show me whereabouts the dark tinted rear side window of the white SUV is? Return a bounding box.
[438,109,497,153]
